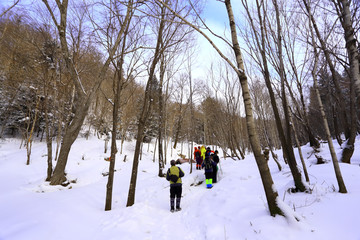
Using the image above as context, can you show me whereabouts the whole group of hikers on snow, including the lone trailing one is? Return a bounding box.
[166,146,220,212]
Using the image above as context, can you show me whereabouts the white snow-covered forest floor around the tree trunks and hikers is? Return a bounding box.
[0,135,360,240]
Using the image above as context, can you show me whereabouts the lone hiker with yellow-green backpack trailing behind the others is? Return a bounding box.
[166,160,185,212]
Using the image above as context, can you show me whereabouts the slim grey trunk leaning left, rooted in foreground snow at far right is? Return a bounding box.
[303,0,347,193]
